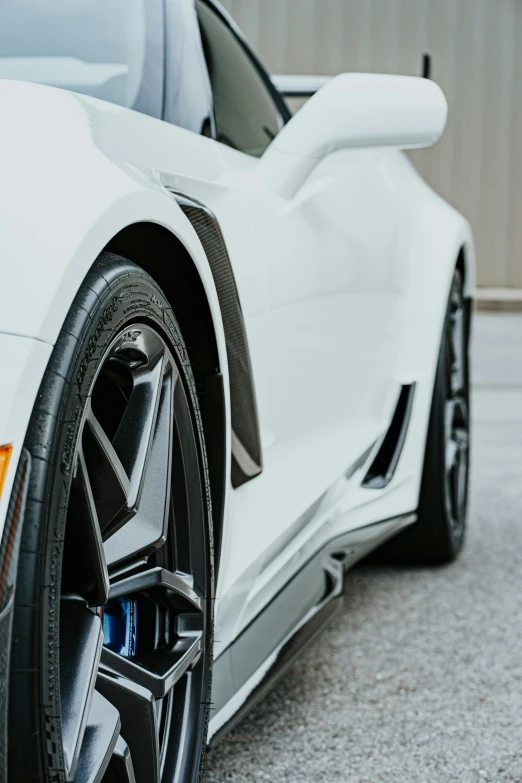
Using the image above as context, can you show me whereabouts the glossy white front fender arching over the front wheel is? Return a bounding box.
[0,76,234,552]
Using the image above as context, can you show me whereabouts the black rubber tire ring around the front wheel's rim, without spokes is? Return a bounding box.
[11,254,213,780]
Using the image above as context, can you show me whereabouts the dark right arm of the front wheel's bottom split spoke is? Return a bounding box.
[96,672,160,783]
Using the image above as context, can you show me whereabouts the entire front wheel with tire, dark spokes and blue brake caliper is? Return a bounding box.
[8,253,213,783]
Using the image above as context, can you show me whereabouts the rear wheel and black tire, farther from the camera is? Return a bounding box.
[377,269,470,564]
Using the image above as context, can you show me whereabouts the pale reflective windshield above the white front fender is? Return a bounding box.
[0,0,163,117]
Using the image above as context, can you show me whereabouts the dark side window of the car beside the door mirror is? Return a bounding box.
[196,0,283,157]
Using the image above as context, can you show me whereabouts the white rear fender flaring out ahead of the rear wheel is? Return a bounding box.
[376,155,476,507]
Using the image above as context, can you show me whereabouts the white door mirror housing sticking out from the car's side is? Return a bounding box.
[262,73,448,197]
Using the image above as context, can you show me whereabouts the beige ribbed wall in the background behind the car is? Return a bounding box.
[222,0,522,288]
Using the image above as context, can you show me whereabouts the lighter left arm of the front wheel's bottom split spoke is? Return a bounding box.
[74,691,120,783]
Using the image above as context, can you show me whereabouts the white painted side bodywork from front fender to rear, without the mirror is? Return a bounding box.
[0,76,475,680]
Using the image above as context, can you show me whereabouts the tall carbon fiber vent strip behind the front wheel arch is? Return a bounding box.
[171,191,262,487]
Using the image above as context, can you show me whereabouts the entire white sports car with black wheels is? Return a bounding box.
[0,0,475,783]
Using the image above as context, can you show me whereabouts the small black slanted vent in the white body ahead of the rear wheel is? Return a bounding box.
[362,383,415,489]
